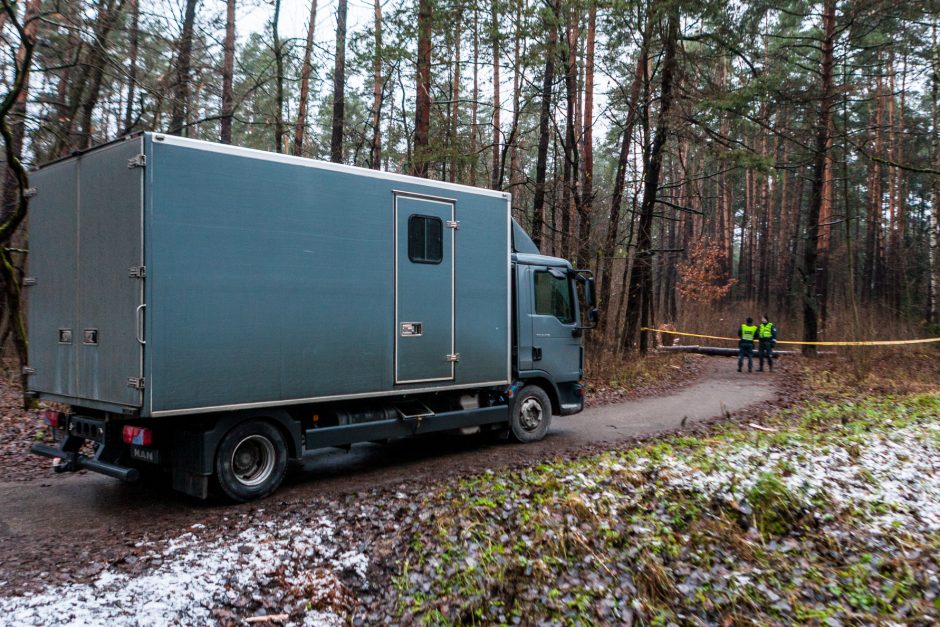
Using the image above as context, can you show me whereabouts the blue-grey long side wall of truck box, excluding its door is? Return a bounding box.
[145,134,509,416]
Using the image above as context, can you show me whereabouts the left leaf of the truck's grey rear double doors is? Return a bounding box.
[26,159,78,397]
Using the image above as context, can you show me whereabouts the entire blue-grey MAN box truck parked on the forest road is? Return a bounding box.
[25,133,594,501]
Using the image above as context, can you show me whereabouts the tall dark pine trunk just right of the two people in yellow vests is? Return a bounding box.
[802,0,836,355]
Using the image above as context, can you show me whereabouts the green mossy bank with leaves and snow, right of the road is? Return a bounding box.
[395,393,940,624]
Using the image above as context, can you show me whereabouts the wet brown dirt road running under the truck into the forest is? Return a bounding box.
[0,358,781,589]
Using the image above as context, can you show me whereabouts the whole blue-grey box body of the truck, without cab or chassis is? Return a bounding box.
[29,133,512,417]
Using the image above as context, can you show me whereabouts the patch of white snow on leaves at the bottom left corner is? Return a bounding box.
[0,518,369,627]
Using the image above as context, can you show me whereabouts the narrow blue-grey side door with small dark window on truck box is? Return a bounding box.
[395,192,457,384]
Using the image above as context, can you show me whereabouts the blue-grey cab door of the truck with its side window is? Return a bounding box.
[529,267,583,383]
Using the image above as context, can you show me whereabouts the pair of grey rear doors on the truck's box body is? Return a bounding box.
[29,137,145,407]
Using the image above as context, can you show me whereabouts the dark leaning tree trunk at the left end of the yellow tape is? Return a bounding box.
[622,6,679,355]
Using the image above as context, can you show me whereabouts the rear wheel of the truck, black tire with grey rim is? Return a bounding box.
[215,420,287,503]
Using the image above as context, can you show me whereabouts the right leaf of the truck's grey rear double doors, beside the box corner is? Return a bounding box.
[74,138,144,407]
